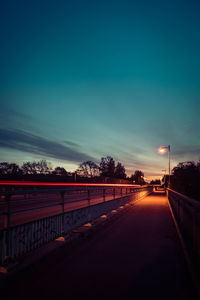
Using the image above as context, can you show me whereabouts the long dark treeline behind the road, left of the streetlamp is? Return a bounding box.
[0,156,145,185]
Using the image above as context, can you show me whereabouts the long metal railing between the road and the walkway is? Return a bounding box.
[0,186,152,265]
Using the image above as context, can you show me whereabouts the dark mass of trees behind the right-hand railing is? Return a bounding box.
[170,161,200,201]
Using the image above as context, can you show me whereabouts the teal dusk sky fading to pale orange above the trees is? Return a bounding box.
[0,0,200,179]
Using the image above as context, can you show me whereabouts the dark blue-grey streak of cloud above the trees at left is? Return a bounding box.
[0,128,93,163]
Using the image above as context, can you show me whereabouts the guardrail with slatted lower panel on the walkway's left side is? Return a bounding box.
[0,186,152,265]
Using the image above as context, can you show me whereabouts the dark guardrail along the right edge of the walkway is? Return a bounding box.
[168,189,200,273]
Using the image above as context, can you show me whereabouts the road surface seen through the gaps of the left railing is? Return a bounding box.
[0,185,136,229]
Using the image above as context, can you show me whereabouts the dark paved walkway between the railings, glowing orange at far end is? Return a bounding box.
[0,192,195,300]
